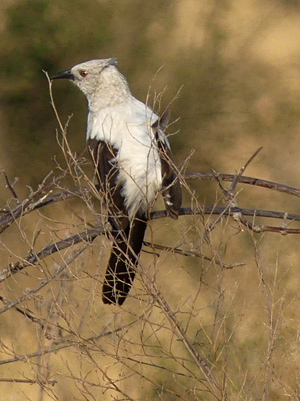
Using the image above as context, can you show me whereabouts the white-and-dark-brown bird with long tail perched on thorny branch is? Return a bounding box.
[50,58,182,305]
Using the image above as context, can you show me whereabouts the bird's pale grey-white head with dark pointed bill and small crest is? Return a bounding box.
[51,58,129,101]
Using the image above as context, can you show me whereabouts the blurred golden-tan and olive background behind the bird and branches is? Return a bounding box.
[0,0,300,401]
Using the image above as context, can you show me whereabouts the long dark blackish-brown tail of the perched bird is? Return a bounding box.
[102,219,147,305]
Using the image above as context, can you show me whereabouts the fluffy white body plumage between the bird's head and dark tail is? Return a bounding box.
[87,98,162,217]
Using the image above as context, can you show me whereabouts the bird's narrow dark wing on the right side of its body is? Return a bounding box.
[152,112,182,219]
